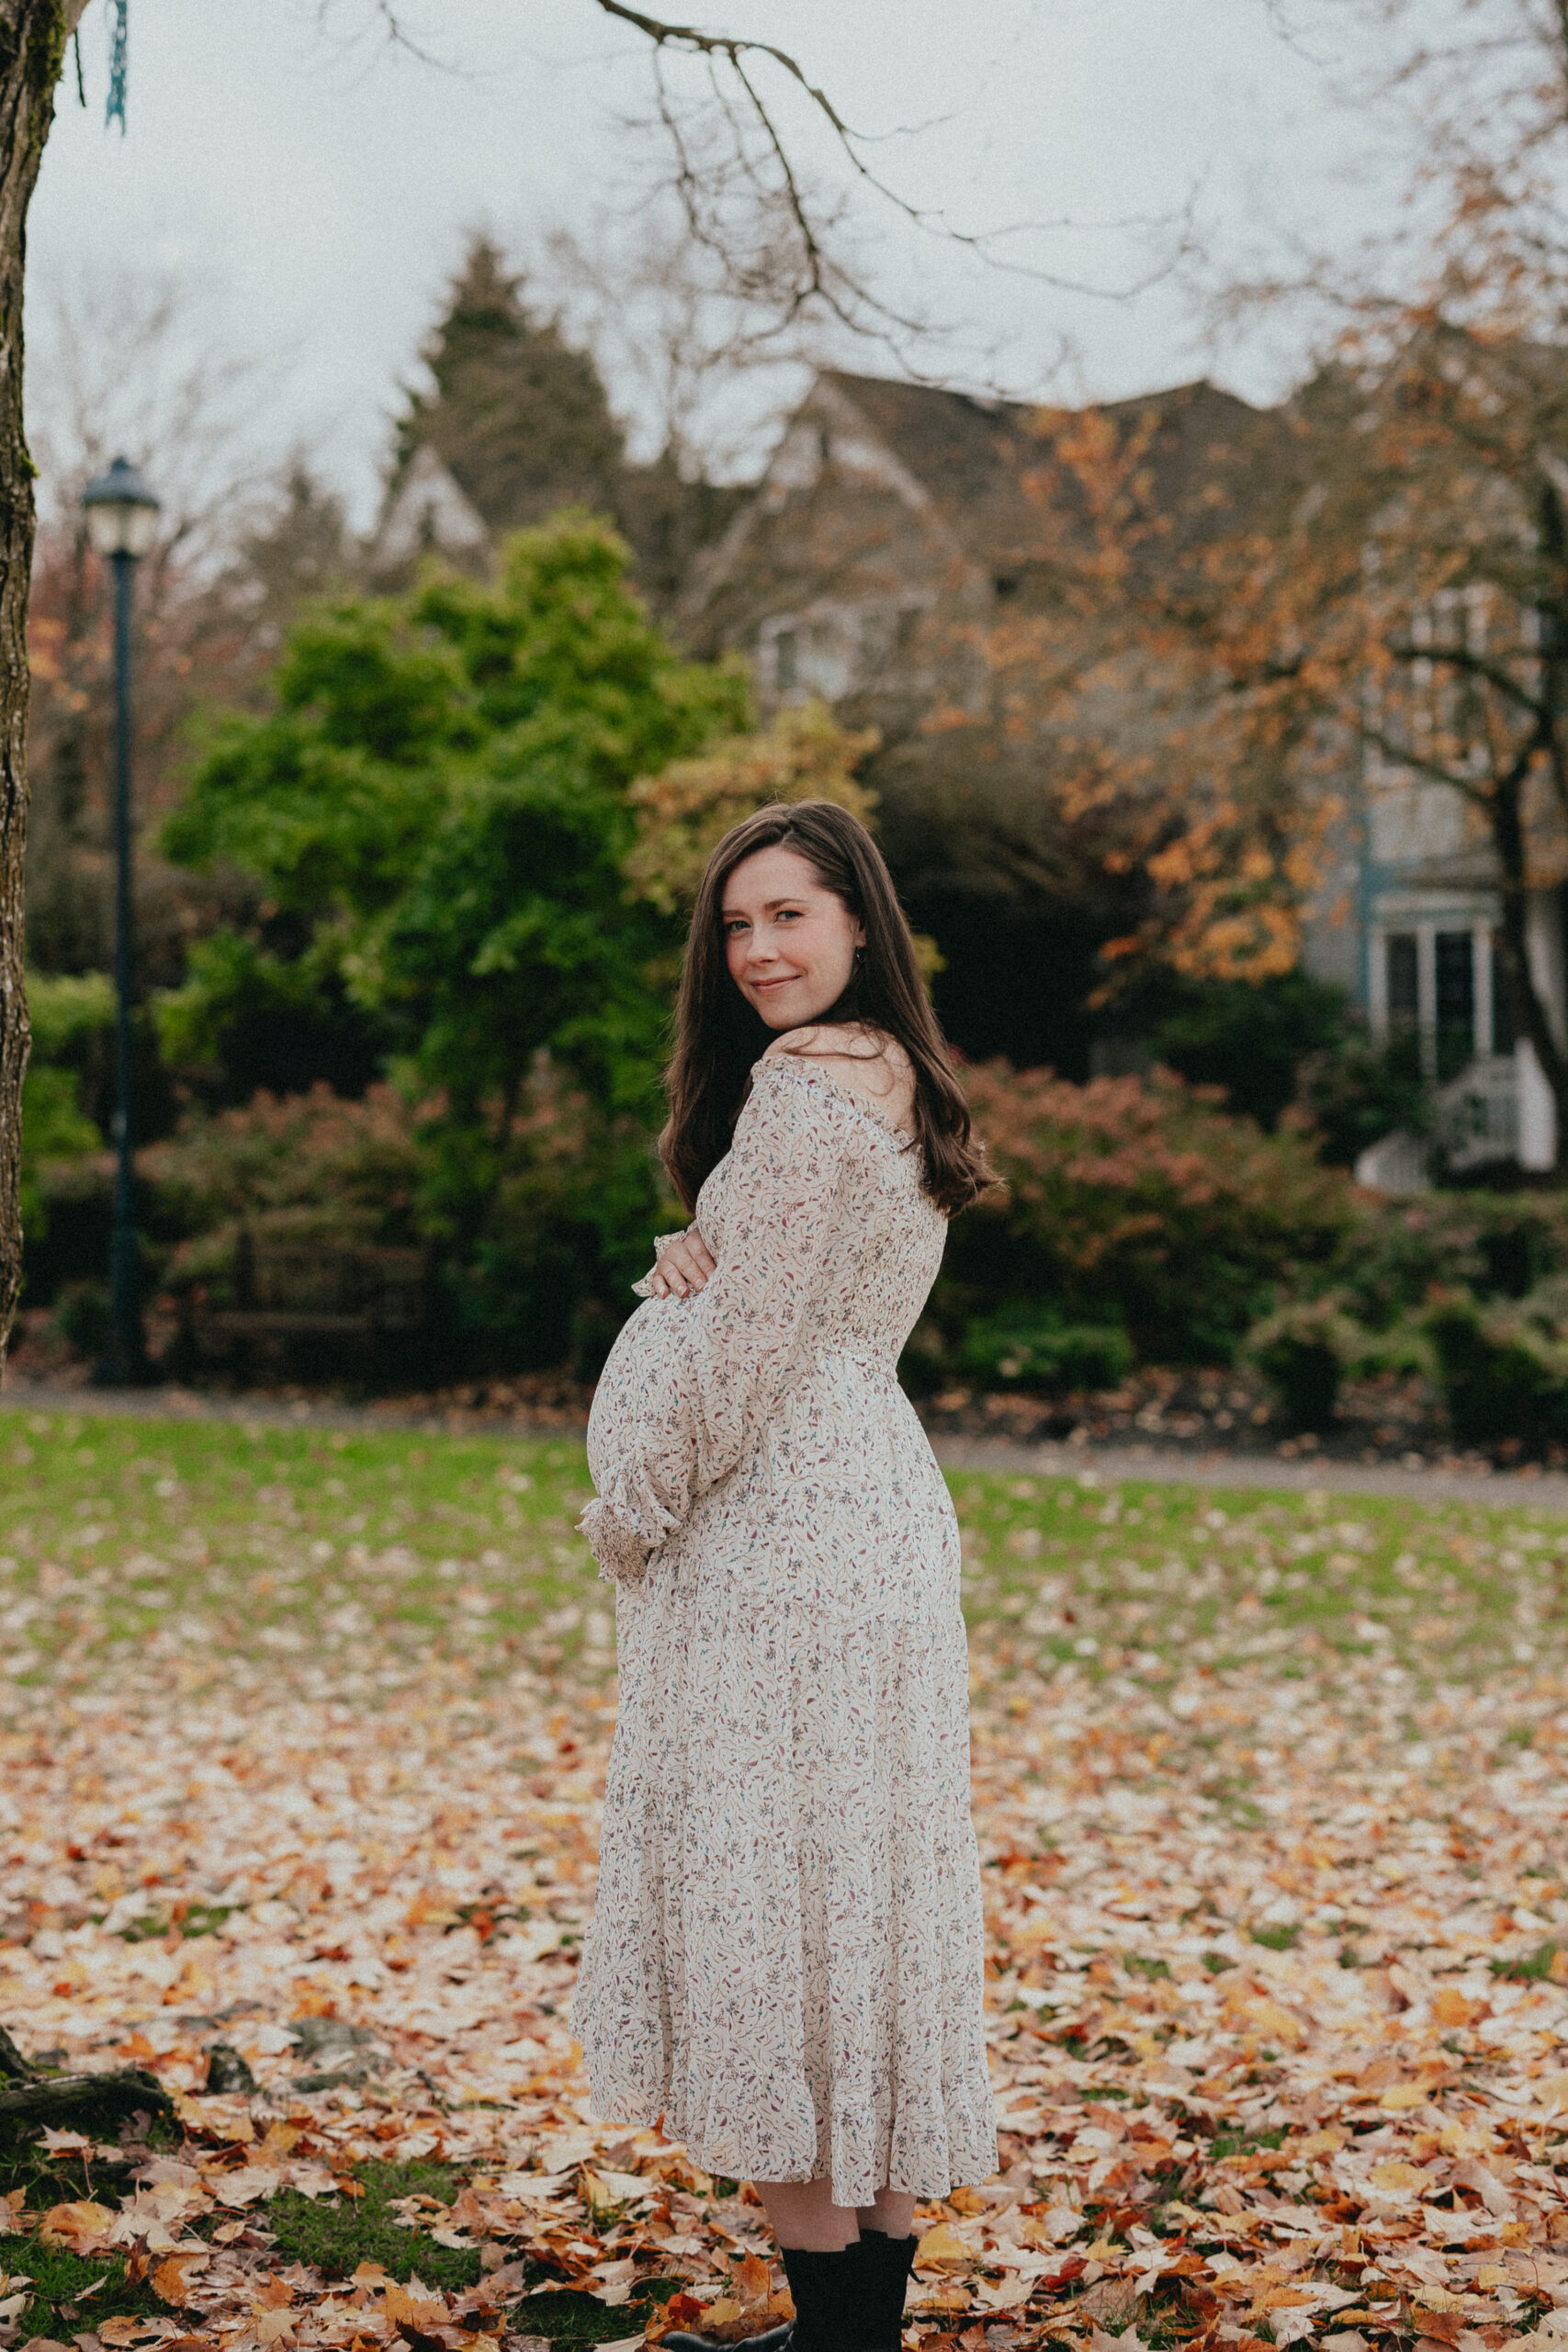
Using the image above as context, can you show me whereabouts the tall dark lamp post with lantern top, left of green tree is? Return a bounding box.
[83,457,157,1385]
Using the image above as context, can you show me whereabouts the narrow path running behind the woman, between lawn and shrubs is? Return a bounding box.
[0,1383,1568,1512]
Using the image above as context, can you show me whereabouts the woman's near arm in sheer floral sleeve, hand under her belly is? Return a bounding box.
[581,1061,861,1574]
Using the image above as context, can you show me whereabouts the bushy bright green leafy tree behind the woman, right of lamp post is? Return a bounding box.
[163,513,748,1352]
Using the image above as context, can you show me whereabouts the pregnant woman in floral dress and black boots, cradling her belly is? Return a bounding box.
[573,799,997,2352]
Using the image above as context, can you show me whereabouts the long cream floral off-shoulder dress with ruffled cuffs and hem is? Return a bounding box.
[571,1056,997,2206]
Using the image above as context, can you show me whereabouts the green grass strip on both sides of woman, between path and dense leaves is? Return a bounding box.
[0,1408,1568,1712]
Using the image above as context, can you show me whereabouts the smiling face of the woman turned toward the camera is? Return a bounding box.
[719,844,865,1030]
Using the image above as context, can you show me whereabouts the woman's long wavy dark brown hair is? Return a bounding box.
[659,799,995,1216]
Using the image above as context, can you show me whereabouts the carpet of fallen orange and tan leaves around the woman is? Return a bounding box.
[0,1448,1568,2352]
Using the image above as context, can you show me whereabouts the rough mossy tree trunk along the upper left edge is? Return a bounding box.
[0,0,87,1362]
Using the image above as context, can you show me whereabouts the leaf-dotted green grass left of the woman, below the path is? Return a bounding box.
[0,1411,614,1702]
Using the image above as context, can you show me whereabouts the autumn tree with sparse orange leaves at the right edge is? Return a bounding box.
[902,0,1568,1176]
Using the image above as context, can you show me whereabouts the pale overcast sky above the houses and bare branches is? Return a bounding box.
[30,0,1382,515]
